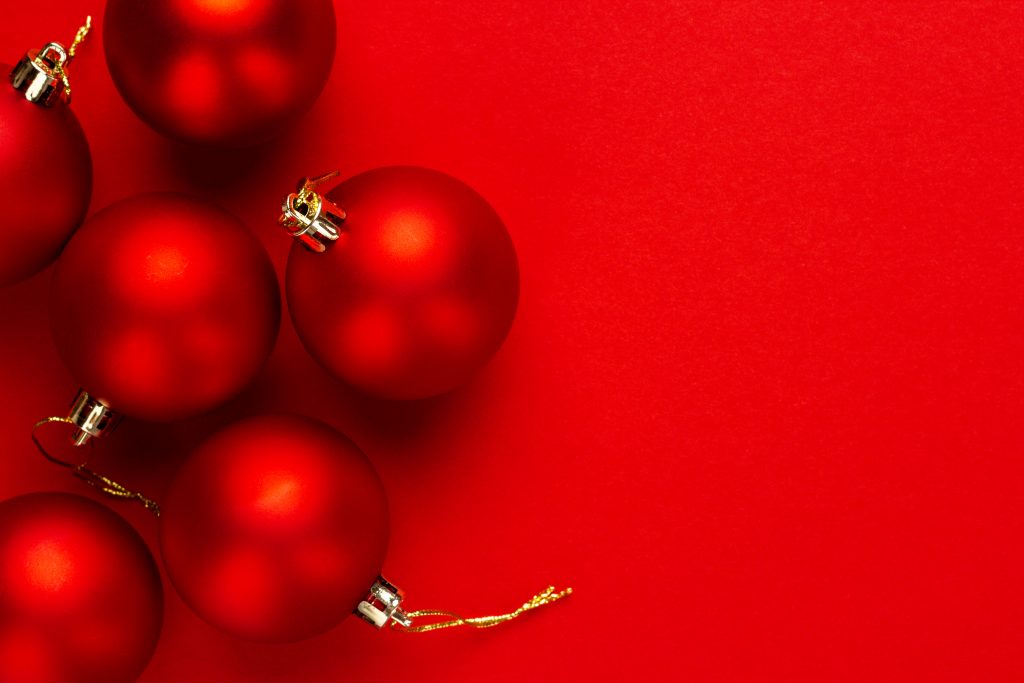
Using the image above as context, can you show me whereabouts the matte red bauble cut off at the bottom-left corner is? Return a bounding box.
[0,494,164,683]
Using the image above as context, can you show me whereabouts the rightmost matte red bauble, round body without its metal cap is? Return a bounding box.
[286,167,519,399]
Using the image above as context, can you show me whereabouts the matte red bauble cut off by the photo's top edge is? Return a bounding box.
[103,0,336,146]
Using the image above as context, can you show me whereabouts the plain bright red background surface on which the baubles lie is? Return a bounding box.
[0,0,1024,683]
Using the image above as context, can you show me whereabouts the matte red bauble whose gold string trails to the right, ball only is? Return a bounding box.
[160,416,388,642]
